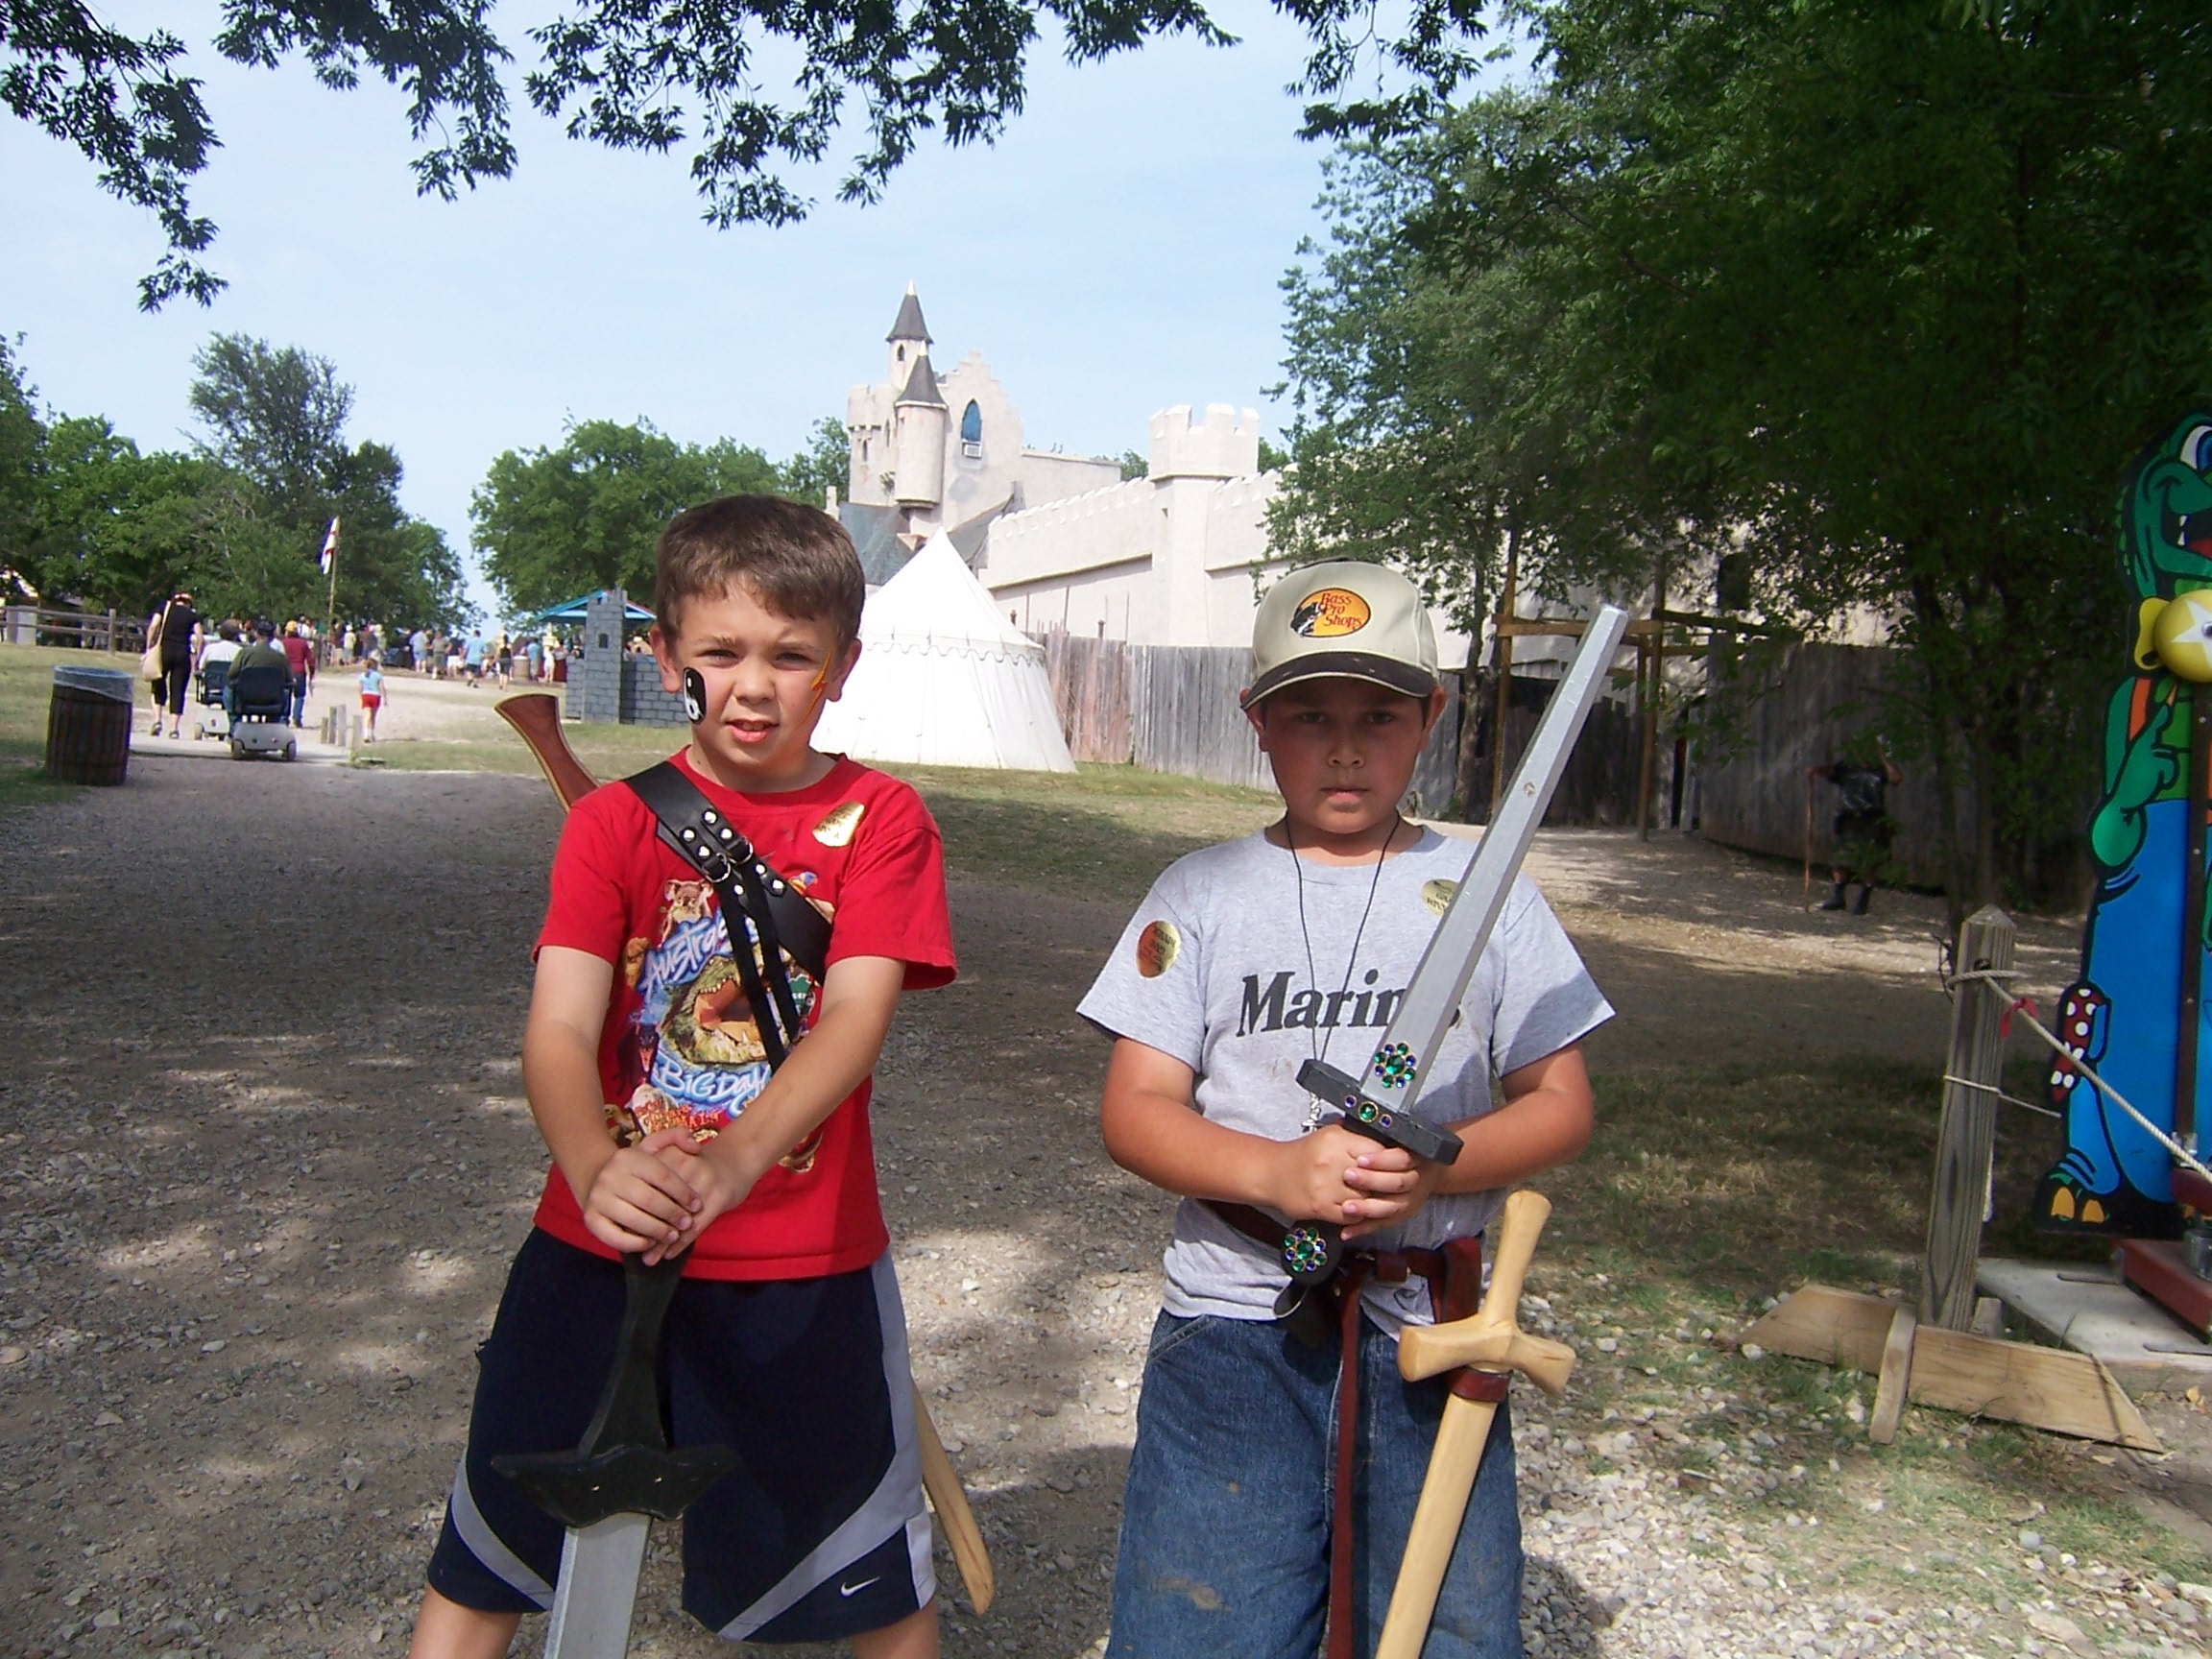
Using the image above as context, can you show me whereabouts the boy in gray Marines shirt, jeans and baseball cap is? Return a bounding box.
[1082,562,1613,1659]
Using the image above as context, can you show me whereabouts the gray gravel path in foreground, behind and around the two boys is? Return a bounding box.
[0,755,2212,1659]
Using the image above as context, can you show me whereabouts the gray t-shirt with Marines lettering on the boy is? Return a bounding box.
[1079,830,1613,1330]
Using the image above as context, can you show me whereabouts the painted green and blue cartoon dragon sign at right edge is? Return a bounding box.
[2035,414,2212,1238]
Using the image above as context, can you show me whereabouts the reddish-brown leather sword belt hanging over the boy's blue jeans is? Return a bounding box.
[1203,1199,1506,1659]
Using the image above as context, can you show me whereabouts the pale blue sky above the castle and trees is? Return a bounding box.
[0,0,1354,602]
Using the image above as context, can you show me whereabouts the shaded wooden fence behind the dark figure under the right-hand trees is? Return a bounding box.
[1696,643,1973,887]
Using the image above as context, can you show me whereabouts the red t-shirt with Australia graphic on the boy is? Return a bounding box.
[538,752,953,1279]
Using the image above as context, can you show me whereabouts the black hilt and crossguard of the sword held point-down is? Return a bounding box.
[491,1257,739,1527]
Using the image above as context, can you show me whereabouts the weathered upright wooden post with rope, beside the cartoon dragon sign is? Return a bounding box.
[1920,904,2017,1332]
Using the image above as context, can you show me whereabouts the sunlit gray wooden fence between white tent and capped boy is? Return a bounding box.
[1042,628,1460,814]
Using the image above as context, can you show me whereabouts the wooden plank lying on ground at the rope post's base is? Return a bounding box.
[1743,1286,2166,1451]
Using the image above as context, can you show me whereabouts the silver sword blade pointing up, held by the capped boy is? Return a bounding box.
[1360,604,1628,1106]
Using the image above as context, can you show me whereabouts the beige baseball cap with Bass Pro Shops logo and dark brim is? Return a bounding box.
[1243,560,1440,708]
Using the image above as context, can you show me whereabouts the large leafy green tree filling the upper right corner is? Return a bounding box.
[1294,0,2212,902]
